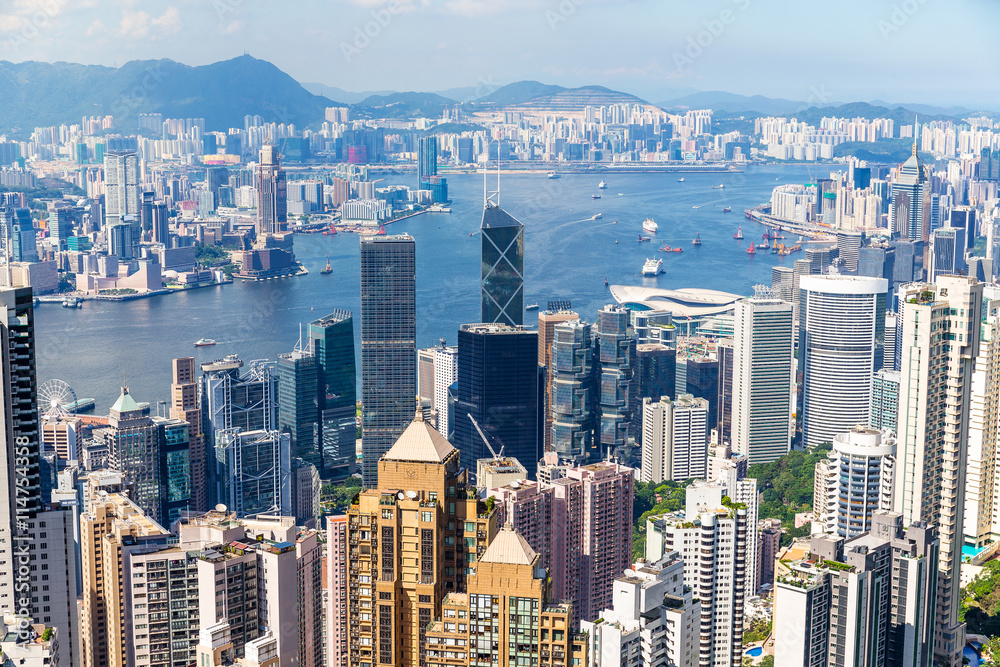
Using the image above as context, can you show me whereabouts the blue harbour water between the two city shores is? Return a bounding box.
[36,166,819,414]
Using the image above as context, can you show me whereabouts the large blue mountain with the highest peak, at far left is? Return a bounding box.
[0,56,344,134]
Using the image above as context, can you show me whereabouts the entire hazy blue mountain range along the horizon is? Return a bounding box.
[0,55,973,137]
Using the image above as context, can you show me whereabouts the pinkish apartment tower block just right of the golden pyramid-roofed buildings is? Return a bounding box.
[487,460,635,627]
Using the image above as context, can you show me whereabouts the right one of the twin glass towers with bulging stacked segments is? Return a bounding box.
[594,305,639,458]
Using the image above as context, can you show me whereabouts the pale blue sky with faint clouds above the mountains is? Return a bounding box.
[0,0,1000,110]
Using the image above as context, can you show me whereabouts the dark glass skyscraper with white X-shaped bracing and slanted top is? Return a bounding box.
[481,202,524,328]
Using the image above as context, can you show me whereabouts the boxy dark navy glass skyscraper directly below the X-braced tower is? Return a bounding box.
[454,324,542,477]
